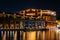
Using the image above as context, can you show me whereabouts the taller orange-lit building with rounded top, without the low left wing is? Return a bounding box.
[17,8,56,28]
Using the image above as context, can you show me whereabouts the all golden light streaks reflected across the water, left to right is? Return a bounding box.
[2,30,60,40]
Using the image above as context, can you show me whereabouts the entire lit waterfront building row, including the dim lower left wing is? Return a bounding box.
[0,8,56,28]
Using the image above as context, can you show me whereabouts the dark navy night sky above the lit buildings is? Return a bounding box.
[0,0,60,19]
